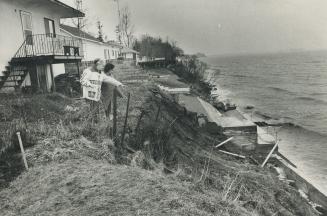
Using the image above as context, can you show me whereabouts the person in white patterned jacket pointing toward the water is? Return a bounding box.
[81,59,123,121]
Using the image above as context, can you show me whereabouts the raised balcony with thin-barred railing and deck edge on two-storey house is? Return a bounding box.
[11,34,84,64]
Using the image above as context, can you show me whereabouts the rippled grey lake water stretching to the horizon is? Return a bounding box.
[202,51,327,194]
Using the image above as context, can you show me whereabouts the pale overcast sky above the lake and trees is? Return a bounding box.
[62,0,327,54]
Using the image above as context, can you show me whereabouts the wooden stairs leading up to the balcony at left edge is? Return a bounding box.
[0,64,28,91]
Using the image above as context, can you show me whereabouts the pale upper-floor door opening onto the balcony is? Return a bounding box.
[20,11,33,56]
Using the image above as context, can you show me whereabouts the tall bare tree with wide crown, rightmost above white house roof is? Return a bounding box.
[118,6,134,47]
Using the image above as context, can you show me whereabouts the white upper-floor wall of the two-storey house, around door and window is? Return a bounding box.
[0,0,60,72]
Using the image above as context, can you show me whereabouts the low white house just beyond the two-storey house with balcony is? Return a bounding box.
[60,24,122,61]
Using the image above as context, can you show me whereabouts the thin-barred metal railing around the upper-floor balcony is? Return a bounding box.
[14,34,83,58]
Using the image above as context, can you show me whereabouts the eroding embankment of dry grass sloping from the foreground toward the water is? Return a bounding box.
[0,72,317,216]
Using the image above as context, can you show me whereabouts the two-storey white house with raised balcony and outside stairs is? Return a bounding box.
[0,0,85,92]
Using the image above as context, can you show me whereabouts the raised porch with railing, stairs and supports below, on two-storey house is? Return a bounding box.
[0,34,84,92]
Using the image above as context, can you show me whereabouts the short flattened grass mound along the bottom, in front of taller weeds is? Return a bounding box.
[0,159,251,215]
